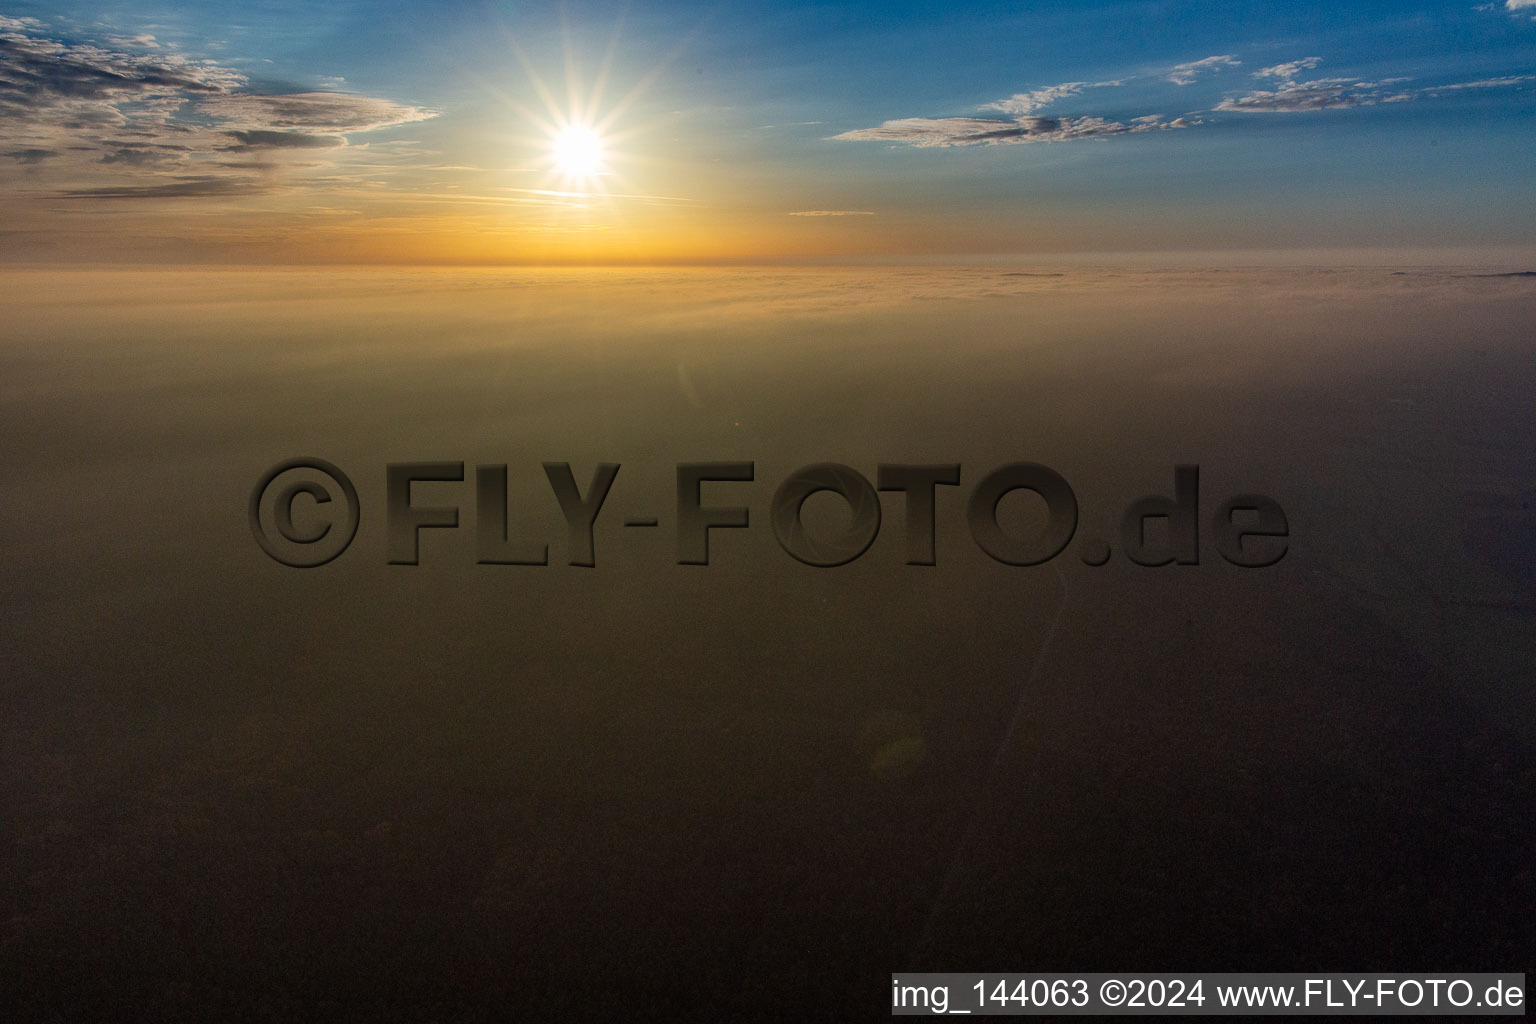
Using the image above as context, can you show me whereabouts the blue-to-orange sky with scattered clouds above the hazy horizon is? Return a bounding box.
[0,0,1536,261]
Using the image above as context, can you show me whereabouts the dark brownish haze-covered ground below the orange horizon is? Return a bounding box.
[0,269,1536,1021]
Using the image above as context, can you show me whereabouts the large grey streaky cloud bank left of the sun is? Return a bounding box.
[0,15,436,200]
